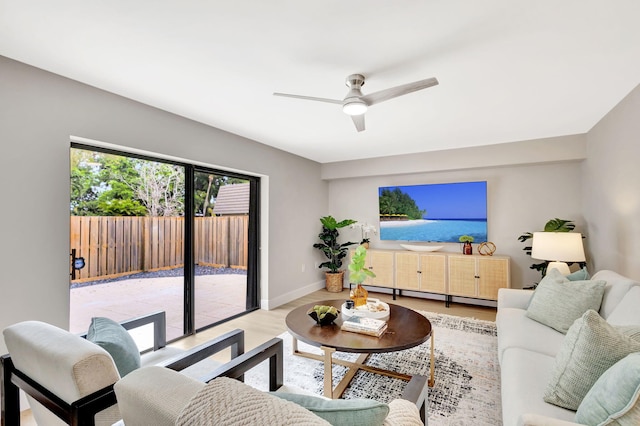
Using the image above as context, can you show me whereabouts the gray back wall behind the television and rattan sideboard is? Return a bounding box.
[323,136,585,288]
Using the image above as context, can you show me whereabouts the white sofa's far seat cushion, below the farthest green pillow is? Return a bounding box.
[496,308,564,363]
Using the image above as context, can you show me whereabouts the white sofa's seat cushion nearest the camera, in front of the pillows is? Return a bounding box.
[500,348,575,426]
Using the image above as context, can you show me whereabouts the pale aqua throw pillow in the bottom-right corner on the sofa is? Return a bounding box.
[576,353,640,426]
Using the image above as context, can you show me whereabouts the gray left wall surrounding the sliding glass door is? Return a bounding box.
[0,57,328,353]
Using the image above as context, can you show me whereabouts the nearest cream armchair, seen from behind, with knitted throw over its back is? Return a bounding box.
[114,339,427,426]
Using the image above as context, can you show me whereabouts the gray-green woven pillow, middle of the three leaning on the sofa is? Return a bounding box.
[544,310,640,411]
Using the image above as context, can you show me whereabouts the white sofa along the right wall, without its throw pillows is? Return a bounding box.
[496,270,640,426]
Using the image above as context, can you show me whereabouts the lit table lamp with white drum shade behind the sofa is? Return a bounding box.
[531,232,585,275]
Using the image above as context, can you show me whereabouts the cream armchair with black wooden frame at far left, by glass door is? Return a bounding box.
[0,312,252,426]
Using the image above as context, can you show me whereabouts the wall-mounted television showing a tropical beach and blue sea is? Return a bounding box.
[378,181,487,243]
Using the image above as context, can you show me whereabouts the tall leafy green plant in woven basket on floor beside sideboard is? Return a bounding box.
[313,216,356,293]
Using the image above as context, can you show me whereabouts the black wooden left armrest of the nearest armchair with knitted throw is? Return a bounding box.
[199,337,284,391]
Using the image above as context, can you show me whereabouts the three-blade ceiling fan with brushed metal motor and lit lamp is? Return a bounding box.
[274,74,438,132]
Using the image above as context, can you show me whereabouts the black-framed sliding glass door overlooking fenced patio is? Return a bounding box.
[70,144,258,340]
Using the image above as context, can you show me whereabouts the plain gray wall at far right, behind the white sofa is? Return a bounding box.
[583,86,640,280]
